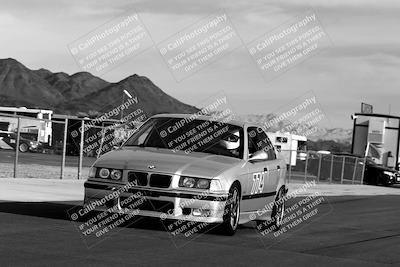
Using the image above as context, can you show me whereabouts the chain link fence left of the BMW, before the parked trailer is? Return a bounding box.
[0,113,114,179]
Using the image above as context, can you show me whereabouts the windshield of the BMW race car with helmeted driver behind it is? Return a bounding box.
[123,118,244,158]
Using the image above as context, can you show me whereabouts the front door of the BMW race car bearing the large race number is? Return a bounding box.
[242,127,281,211]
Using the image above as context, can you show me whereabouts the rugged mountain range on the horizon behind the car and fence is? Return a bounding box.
[0,58,351,143]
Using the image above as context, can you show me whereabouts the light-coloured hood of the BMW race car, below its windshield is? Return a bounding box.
[95,147,242,178]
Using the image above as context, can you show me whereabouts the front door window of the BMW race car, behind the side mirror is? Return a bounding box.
[247,127,276,160]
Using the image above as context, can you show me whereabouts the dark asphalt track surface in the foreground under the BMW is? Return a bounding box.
[0,195,400,266]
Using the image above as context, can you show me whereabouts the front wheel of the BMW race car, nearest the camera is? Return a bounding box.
[220,184,240,236]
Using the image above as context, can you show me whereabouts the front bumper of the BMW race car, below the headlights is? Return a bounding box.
[84,181,228,223]
